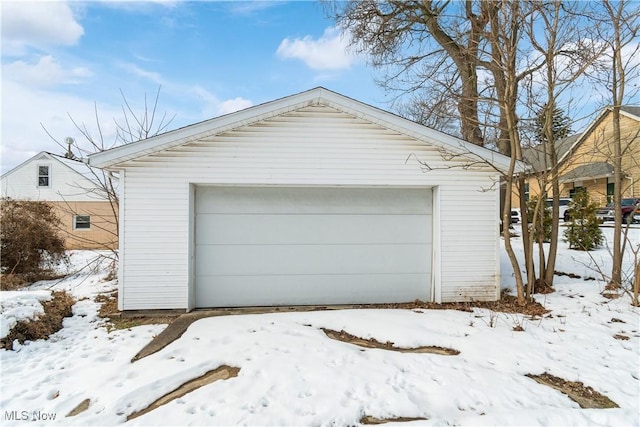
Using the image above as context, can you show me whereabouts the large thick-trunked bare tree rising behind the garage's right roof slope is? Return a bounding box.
[327,0,499,145]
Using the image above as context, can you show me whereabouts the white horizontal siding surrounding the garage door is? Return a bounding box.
[120,106,499,310]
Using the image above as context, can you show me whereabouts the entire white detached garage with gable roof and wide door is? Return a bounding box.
[89,88,510,310]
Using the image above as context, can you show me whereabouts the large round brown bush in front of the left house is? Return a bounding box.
[0,198,67,281]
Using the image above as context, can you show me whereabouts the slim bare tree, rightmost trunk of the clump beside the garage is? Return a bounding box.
[525,0,602,294]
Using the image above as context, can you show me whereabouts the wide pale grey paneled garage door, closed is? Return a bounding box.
[195,186,432,307]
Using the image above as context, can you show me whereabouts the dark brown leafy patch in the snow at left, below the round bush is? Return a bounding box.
[0,291,75,350]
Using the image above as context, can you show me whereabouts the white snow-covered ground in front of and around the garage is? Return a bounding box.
[0,229,640,426]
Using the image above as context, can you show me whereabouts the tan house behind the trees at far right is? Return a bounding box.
[512,106,640,207]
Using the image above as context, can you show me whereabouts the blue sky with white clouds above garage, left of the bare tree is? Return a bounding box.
[0,1,389,172]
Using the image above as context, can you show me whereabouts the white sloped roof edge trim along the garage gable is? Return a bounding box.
[88,87,524,170]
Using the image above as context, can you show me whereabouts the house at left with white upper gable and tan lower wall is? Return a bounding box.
[0,151,118,249]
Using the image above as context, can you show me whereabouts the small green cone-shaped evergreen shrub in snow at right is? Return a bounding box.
[564,191,603,251]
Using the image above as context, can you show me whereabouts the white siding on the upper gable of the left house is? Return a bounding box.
[1,154,103,202]
